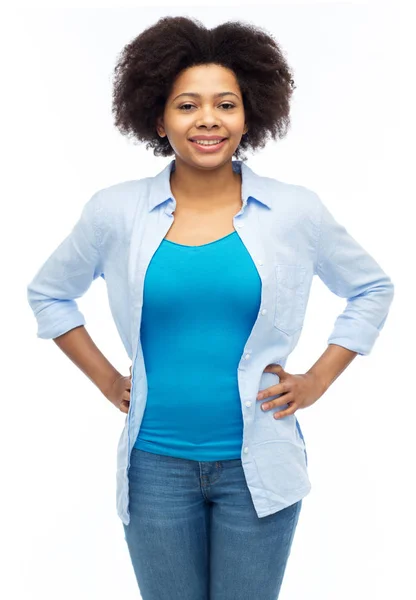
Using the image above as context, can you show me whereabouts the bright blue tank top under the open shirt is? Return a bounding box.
[134,231,261,461]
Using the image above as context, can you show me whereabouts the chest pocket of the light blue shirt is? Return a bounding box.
[274,264,306,335]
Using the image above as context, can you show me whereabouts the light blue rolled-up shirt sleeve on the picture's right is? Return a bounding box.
[315,196,394,355]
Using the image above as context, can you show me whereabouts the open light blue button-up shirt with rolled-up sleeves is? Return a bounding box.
[27,159,394,525]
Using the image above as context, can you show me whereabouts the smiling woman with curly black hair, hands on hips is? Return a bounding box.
[28,17,394,600]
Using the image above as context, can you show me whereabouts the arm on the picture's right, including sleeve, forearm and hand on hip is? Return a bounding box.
[257,198,394,418]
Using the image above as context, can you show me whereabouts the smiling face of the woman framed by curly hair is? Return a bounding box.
[157,64,248,169]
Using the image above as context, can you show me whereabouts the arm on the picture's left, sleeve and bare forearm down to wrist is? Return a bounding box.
[27,192,120,395]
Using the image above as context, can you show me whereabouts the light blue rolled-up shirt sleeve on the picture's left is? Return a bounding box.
[27,192,104,339]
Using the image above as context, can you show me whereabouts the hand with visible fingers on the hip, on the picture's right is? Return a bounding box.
[257,364,326,419]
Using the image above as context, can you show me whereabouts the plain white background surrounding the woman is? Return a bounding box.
[0,2,416,600]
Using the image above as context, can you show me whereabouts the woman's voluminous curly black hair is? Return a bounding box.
[112,16,296,160]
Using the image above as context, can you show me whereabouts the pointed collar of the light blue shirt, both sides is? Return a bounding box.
[148,159,271,212]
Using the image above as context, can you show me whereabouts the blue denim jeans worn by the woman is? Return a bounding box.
[123,447,302,600]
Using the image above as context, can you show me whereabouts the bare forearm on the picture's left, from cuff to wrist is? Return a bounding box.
[53,325,121,396]
